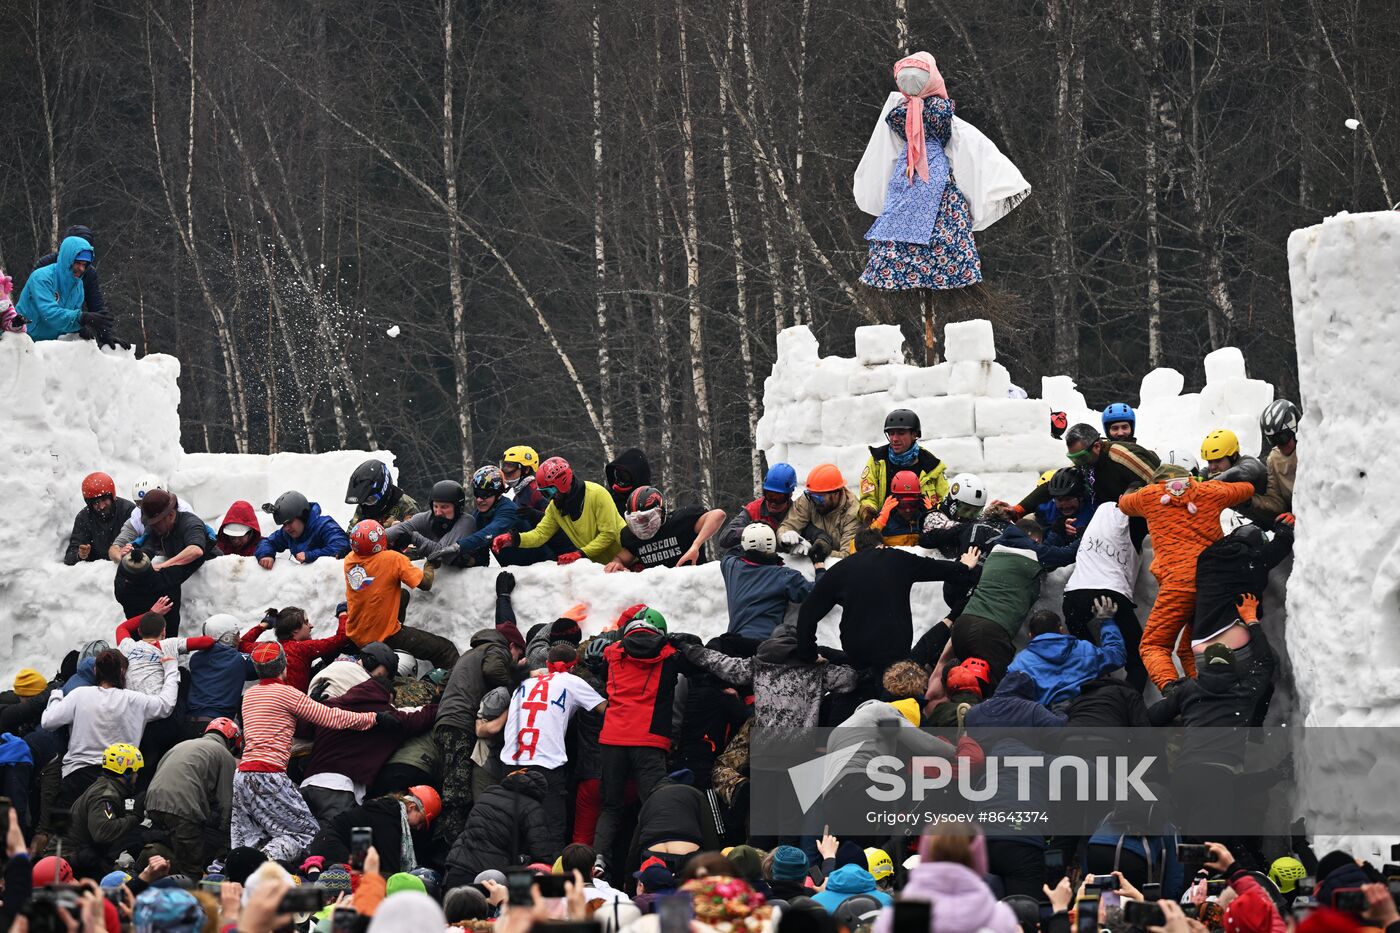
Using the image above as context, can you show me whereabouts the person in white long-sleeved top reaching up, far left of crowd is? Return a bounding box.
[39,649,179,811]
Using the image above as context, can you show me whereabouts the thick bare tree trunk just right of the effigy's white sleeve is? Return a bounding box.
[1046,0,1084,375]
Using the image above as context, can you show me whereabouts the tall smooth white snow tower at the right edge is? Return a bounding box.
[1288,212,1400,864]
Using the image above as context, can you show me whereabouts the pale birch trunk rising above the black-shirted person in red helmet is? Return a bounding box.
[676,0,714,504]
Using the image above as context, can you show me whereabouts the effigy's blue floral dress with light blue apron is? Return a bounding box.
[861,97,981,290]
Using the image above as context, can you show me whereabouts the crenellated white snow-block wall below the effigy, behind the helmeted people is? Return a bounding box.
[757,321,1274,502]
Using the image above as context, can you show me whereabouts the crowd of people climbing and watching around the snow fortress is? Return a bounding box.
[10,281,1400,933]
